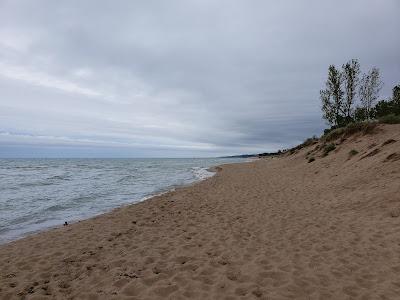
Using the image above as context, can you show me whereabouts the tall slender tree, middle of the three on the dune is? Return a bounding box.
[342,59,360,123]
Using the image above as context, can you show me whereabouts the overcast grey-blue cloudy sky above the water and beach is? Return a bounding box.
[0,0,400,157]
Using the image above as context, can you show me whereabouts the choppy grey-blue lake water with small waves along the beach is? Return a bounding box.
[0,159,241,243]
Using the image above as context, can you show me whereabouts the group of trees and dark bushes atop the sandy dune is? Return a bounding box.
[320,59,400,130]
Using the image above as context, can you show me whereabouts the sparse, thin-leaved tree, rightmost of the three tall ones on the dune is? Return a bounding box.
[358,68,382,120]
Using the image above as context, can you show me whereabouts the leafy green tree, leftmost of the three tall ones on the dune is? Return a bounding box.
[320,65,344,126]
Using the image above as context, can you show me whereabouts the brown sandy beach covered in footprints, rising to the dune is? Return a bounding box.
[0,125,400,299]
